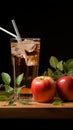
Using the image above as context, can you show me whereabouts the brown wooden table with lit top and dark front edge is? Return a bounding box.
[0,101,73,119]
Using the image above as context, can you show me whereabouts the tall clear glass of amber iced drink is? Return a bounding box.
[10,38,40,99]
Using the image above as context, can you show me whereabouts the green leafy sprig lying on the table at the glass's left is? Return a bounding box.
[0,72,24,105]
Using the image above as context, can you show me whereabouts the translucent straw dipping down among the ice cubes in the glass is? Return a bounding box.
[11,19,27,63]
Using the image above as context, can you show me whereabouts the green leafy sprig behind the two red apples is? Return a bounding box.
[46,56,73,80]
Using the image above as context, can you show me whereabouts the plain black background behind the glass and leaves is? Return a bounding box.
[0,1,73,79]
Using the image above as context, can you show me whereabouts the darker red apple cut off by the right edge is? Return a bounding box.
[57,75,73,101]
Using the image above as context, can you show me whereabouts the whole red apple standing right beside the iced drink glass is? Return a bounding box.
[31,76,56,103]
